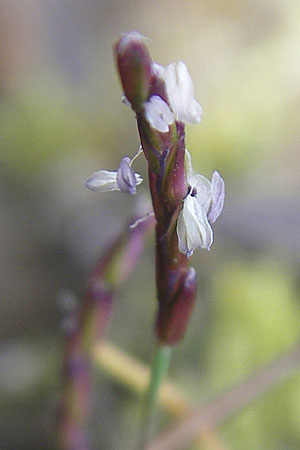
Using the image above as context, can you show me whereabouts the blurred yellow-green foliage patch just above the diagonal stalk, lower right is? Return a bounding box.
[209,260,300,388]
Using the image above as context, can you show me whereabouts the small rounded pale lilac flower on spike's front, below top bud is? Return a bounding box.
[144,95,175,133]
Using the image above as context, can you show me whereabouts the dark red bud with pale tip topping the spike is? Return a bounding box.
[115,31,152,112]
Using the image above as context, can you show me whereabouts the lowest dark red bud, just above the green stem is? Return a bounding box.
[156,267,197,345]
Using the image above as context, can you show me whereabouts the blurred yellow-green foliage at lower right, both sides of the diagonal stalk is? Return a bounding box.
[207,259,300,450]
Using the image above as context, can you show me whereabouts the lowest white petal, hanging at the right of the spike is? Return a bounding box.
[177,195,213,257]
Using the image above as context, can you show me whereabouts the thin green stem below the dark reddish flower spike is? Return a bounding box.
[138,343,171,450]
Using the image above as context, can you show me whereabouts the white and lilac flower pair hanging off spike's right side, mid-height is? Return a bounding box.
[177,150,225,257]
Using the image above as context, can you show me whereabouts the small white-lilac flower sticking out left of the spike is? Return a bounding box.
[85,148,143,194]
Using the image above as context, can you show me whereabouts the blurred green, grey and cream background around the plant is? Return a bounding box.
[0,0,300,450]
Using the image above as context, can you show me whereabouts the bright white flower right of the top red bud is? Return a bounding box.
[152,61,202,123]
